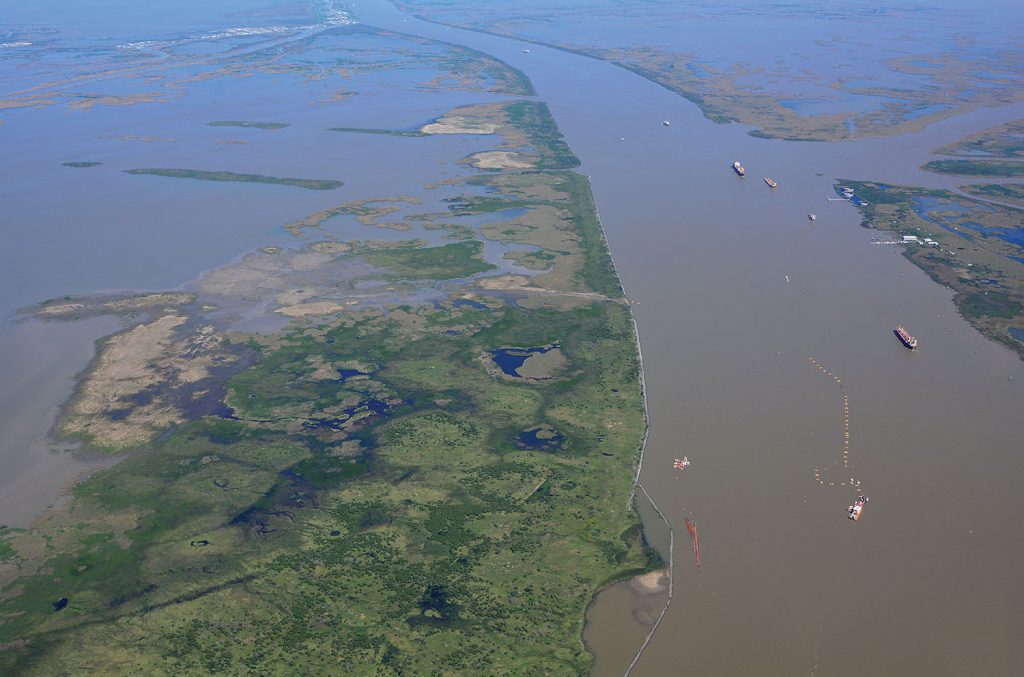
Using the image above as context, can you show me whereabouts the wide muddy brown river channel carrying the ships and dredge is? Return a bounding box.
[356,2,1024,675]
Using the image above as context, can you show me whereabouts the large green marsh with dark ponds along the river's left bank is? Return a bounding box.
[0,39,647,675]
